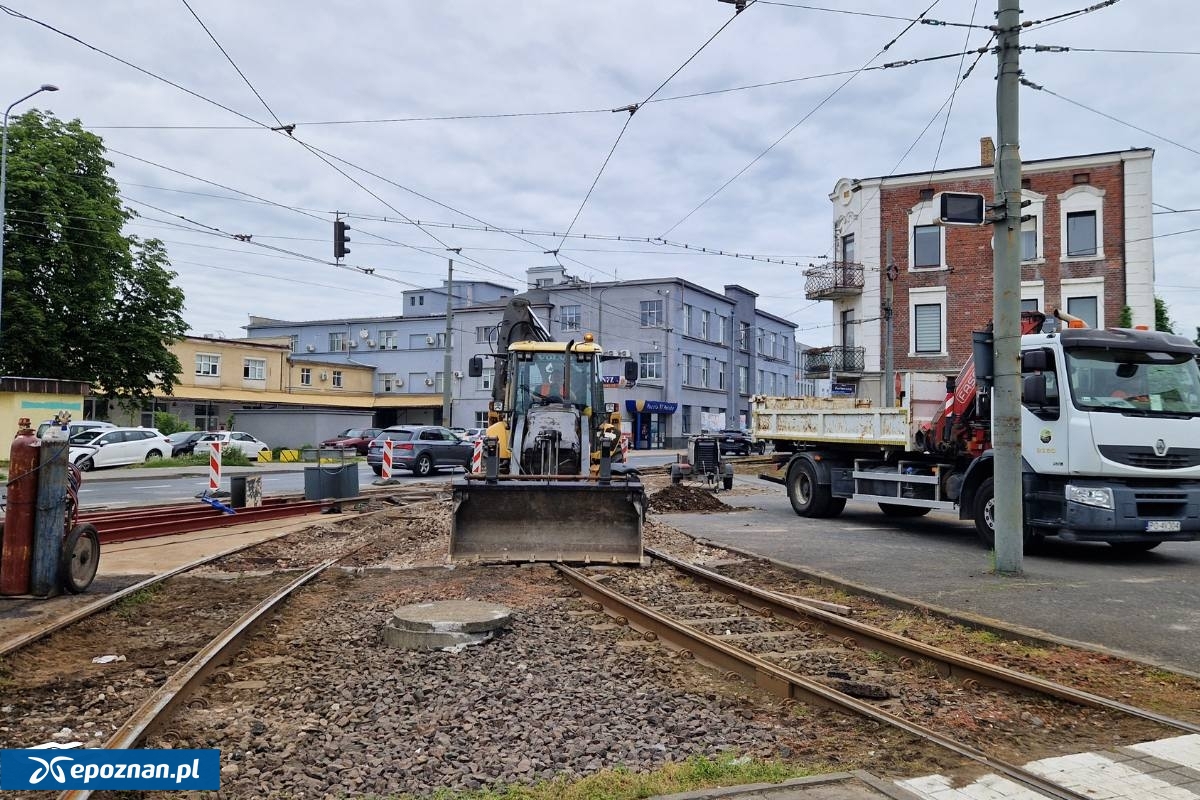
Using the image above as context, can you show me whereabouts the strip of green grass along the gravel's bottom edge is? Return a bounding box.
[374,756,811,800]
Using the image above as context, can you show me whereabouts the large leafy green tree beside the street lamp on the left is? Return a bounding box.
[0,110,187,399]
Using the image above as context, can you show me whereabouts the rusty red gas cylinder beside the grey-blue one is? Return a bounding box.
[0,419,42,595]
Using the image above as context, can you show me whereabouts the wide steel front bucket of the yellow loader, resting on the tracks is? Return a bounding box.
[450,475,646,564]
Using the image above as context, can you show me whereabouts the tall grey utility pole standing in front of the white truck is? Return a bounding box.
[991,0,1024,575]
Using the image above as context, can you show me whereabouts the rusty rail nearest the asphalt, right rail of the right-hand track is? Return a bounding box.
[646,548,1200,733]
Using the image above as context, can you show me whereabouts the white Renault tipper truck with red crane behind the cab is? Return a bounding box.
[752,309,1200,552]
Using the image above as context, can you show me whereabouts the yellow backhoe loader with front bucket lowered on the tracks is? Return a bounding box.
[450,295,646,564]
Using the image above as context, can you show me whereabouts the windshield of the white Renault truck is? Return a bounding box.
[1067,348,1200,416]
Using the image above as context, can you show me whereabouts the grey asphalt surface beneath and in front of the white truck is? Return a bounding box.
[666,476,1200,673]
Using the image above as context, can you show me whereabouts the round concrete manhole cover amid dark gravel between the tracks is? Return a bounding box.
[383,600,512,650]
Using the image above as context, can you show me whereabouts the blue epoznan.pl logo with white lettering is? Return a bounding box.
[0,748,221,790]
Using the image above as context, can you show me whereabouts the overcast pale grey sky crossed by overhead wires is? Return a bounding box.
[0,0,1200,344]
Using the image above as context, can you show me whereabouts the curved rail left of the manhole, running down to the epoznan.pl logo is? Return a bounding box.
[59,554,355,800]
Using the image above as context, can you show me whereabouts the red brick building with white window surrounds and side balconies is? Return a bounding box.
[804,138,1154,393]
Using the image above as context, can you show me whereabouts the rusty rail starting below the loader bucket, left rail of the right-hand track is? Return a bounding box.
[554,564,1087,800]
